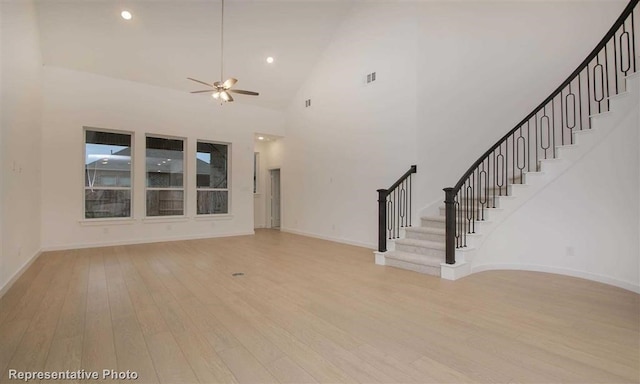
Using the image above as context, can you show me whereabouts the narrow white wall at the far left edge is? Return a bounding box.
[0,1,42,292]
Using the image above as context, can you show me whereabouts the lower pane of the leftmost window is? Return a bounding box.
[84,189,131,219]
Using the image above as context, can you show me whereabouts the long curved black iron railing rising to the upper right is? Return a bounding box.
[444,0,639,264]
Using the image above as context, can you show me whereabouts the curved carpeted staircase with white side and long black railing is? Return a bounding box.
[376,0,640,280]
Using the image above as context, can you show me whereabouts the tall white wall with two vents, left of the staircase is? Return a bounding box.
[282,3,417,247]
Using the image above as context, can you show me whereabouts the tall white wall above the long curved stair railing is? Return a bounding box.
[416,1,627,212]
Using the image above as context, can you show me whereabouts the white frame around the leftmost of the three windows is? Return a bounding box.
[80,126,135,222]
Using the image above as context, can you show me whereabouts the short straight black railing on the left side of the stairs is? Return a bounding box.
[378,165,417,252]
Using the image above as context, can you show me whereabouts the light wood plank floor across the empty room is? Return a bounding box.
[0,230,640,383]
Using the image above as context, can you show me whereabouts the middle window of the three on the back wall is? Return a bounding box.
[146,136,184,216]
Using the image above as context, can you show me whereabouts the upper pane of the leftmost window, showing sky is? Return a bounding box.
[84,131,131,189]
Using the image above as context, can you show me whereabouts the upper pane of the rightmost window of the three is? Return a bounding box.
[196,142,228,189]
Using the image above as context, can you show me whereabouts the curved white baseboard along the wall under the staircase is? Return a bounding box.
[471,263,640,293]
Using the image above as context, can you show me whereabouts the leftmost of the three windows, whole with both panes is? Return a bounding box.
[84,129,131,219]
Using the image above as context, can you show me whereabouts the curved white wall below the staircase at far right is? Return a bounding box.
[472,79,640,292]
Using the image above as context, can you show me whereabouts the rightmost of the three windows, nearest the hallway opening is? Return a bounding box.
[196,141,229,215]
